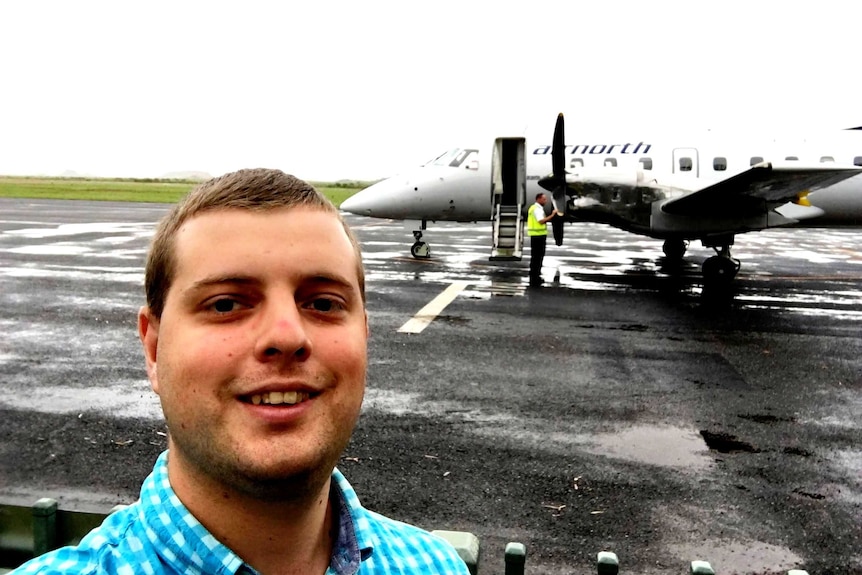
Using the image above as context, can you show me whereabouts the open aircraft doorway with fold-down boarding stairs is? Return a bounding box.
[490,138,527,261]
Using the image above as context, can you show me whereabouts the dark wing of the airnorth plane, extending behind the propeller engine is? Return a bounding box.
[661,162,862,217]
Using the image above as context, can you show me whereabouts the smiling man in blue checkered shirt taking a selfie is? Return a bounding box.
[11,169,467,575]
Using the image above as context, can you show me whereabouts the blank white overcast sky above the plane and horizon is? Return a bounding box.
[0,0,862,180]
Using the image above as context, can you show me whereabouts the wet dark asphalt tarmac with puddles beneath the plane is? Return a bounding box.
[0,200,862,575]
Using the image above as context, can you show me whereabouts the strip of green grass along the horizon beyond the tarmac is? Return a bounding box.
[0,176,372,212]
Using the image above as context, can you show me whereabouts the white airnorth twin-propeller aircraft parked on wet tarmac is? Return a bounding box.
[341,114,862,284]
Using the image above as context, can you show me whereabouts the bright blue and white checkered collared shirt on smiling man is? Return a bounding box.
[12,451,468,575]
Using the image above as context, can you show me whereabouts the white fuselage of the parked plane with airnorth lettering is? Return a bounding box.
[342,130,862,231]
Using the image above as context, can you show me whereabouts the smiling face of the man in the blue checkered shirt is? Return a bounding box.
[139,207,368,500]
